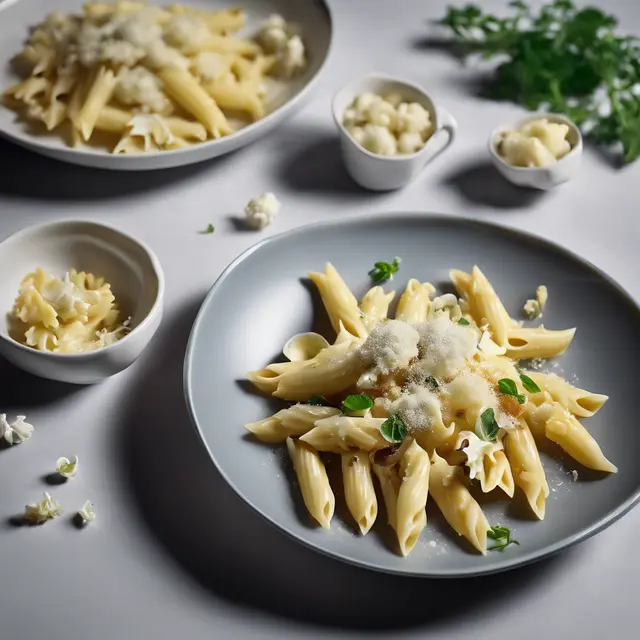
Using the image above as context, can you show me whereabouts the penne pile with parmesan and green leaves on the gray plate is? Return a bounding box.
[246,264,617,555]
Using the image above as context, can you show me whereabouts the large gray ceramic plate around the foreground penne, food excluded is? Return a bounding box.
[185,214,640,577]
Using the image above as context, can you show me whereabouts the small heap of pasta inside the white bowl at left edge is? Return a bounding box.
[11,267,130,353]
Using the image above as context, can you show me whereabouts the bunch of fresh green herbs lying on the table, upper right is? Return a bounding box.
[440,0,640,162]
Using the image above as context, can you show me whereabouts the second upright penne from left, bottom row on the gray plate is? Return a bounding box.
[342,451,378,536]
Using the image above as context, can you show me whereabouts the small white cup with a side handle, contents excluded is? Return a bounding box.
[332,73,457,191]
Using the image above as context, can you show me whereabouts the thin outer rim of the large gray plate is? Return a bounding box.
[183,210,640,579]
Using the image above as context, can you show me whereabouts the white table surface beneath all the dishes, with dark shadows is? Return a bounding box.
[0,0,640,640]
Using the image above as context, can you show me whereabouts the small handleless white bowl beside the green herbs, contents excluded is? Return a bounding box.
[489,113,582,191]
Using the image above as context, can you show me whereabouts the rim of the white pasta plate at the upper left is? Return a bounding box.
[0,0,335,171]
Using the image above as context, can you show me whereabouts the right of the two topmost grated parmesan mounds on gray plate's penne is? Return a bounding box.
[416,314,477,378]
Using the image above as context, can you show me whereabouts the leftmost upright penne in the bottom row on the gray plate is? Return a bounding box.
[287,438,335,529]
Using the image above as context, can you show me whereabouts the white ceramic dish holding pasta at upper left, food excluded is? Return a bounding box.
[0,0,333,171]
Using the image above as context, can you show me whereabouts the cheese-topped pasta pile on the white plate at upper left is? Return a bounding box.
[4,0,305,154]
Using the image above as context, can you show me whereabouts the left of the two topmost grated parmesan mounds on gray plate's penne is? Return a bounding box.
[360,320,420,376]
